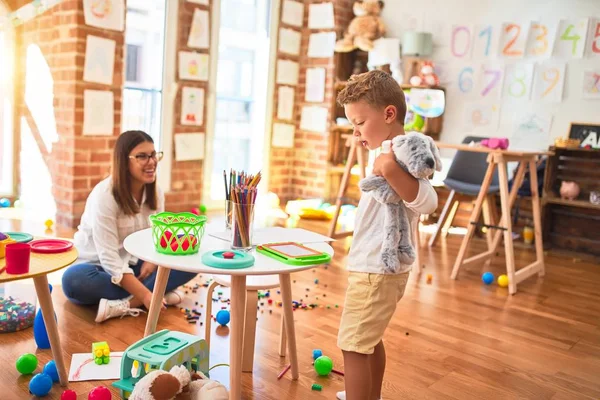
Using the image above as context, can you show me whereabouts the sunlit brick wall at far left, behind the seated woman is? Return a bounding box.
[10,0,124,227]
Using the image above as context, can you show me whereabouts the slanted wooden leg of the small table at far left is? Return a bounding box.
[33,275,69,386]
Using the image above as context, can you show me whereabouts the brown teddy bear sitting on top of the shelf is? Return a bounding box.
[335,0,386,53]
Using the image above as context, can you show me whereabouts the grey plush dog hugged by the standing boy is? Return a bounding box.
[359,132,442,273]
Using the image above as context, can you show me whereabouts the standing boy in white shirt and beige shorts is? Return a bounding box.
[337,70,437,400]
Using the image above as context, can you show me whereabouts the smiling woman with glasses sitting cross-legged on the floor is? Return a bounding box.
[62,131,196,322]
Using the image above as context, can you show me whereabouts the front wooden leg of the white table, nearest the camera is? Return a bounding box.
[229,275,246,400]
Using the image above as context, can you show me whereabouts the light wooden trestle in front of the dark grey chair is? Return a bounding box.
[451,151,545,294]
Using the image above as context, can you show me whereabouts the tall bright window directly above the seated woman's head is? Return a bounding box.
[122,0,167,148]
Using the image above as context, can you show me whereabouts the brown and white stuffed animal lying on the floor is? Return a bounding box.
[129,365,229,400]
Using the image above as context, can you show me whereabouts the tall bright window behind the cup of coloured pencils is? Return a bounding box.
[203,0,271,207]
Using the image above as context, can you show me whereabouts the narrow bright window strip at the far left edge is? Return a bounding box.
[0,1,15,197]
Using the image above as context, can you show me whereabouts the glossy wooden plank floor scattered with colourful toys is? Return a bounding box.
[0,216,600,400]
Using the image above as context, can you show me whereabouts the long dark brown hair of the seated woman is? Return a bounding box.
[112,131,157,215]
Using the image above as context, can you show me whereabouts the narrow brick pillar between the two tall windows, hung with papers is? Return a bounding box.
[165,0,211,212]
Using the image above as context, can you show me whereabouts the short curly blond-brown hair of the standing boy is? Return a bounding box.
[337,69,406,125]
